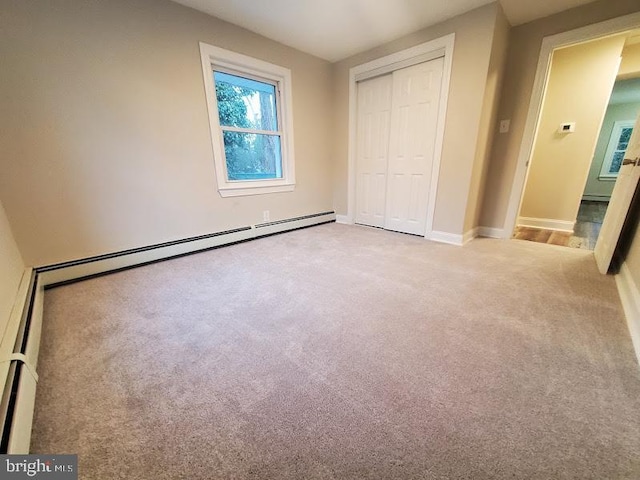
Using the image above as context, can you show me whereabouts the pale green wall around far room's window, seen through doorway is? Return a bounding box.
[584,103,640,198]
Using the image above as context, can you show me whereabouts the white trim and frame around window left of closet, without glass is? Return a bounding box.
[200,42,295,197]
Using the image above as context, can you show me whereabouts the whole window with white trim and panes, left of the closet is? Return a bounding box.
[200,43,295,197]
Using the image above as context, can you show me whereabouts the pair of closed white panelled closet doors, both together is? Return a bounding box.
[355,58,444,235]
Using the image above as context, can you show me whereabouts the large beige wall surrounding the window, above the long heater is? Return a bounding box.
[0,0,332,265]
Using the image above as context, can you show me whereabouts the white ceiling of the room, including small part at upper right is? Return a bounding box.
[174,0,594,62]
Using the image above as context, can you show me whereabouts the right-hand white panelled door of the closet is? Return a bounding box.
[384,58,444,235]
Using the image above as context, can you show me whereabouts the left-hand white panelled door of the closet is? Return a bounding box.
[355,73,392,227]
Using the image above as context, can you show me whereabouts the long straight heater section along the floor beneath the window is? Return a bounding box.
[36,212,336,287]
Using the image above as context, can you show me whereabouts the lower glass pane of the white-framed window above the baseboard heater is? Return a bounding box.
[222,132,282,180]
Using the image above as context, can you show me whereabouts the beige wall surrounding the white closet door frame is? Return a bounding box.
[333,3,499,234]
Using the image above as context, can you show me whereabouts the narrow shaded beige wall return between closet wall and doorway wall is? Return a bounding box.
[464,8,511,233]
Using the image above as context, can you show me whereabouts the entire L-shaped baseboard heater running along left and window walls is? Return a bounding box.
[0,212,336,454]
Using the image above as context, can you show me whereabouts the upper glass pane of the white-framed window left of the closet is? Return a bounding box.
[213,72,278,131]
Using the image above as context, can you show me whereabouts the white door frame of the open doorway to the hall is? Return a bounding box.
[503,12,640,238]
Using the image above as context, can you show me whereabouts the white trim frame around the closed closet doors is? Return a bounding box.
[344,33,455,238]
